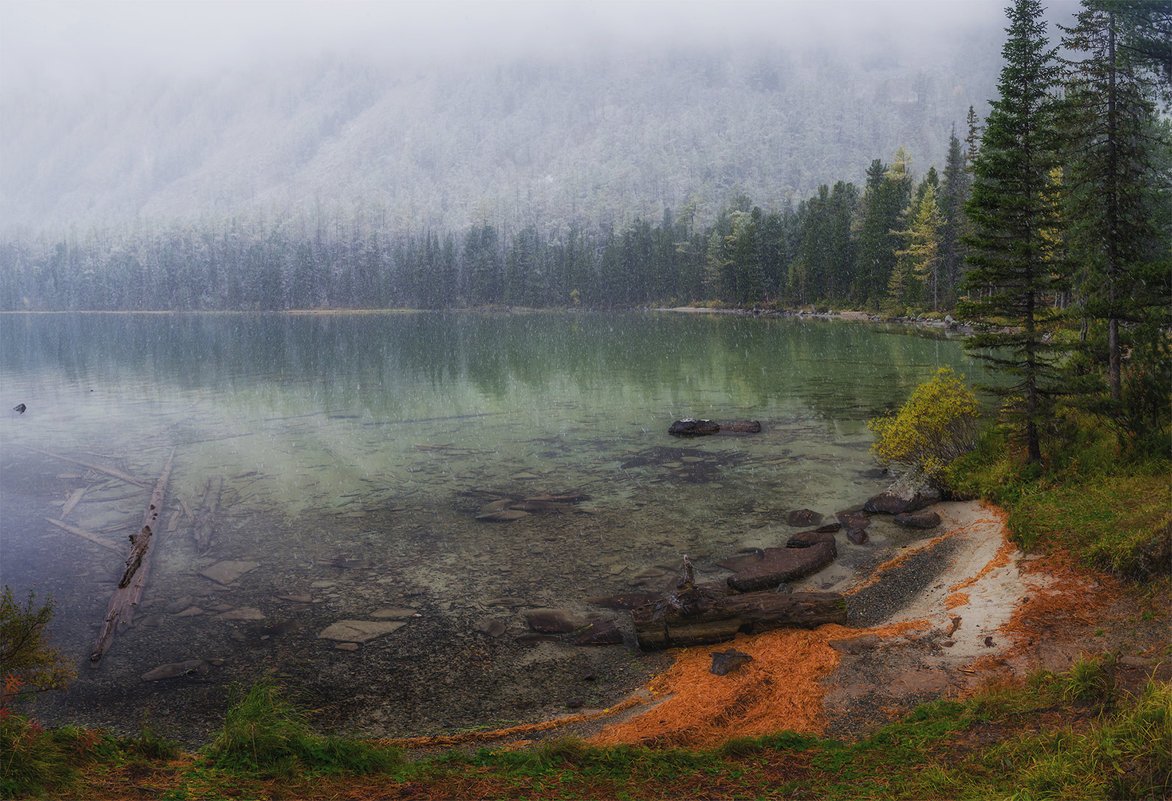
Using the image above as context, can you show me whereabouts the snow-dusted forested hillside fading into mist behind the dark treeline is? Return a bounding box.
[0,36,1001,235]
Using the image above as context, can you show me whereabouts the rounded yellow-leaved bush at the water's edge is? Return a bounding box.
[867,367,979,481]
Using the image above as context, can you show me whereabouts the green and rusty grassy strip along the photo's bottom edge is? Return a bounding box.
[0,658,1172,801]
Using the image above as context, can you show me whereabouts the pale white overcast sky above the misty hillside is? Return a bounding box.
[0,0,1008,88]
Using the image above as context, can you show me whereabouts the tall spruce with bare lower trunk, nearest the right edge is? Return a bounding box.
[1062,0,1168,402]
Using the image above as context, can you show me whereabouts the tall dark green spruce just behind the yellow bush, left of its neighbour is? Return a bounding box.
[963,0,1064,463]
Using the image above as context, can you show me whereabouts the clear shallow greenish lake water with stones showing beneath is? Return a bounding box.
[0,312,982,741]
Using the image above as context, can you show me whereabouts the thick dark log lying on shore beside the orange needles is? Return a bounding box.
[631,592,846,651]
